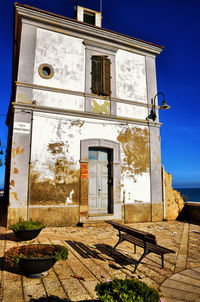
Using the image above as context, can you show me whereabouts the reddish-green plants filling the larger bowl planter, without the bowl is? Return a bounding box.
[5,244,68,265]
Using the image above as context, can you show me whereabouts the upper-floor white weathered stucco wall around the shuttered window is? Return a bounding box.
[30,28,148,119]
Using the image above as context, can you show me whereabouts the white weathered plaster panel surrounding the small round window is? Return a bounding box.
[34,28,85,92]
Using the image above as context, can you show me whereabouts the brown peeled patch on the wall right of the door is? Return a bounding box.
[117,126,150,181]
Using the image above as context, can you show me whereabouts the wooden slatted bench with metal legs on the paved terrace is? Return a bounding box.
[105,220,175,272]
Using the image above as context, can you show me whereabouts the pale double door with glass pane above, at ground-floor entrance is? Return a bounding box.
[88,148,110,214]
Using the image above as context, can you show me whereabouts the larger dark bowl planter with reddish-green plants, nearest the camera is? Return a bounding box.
[5,244,68,277]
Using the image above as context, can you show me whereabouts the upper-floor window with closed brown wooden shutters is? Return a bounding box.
[91,56,111,95]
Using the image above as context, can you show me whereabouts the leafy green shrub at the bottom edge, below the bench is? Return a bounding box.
[95,279,160,302]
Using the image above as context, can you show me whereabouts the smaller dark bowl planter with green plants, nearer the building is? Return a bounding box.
[9,219,44,241]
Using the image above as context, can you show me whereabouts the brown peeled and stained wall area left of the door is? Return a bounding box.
[30,142,80,205]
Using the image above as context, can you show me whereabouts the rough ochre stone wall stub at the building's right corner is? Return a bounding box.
[163,170,185,220]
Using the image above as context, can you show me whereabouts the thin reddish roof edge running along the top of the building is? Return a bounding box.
[14,2,164,49]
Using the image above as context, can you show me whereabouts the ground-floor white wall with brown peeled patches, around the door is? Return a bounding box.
[30,114,150,206]
